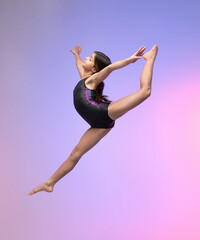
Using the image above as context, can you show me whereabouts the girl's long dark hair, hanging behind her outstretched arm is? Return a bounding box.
[94,51,112,103]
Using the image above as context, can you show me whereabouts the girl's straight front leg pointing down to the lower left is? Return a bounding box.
[29,128,112,195]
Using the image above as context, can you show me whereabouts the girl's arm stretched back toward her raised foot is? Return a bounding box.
[91,46,146,86]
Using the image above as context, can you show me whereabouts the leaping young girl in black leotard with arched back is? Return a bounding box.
[29,45,158,195]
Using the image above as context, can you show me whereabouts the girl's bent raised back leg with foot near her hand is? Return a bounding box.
[108,45,158,120]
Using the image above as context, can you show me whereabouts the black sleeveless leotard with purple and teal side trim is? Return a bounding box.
[73,77,115,128]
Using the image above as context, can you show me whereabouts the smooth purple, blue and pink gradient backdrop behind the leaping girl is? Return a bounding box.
[0,0,200,240]
